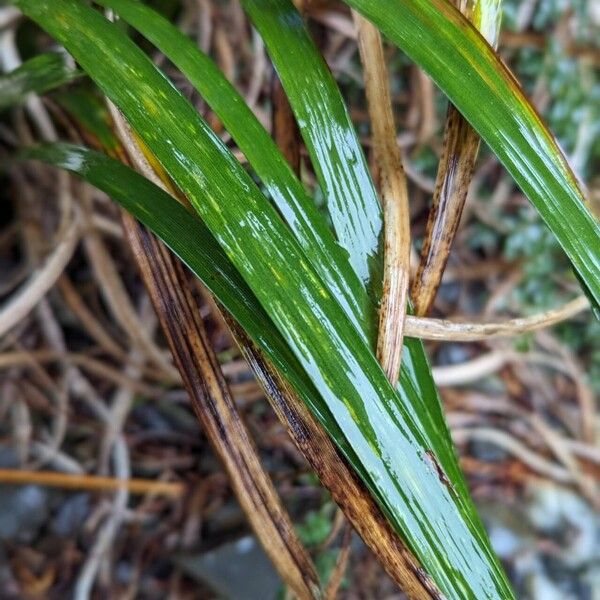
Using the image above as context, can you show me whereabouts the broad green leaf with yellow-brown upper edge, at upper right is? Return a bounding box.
[345,0,600,303]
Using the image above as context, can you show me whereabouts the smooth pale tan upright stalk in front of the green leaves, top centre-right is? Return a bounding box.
[353,11,410,386]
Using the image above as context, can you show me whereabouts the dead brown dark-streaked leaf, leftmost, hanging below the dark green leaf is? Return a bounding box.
[113,111,321,600]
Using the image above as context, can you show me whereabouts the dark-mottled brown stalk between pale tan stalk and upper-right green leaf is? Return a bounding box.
[411,0,496,316]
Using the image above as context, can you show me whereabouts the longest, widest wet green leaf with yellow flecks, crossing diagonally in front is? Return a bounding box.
[18,0,511,598]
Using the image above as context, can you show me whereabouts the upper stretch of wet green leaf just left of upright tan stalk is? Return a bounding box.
[241,0,383,298]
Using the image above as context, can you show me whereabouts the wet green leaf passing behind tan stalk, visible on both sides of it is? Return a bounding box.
[233,0,460,482]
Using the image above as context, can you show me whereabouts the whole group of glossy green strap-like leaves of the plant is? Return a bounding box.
[4,0,600,598]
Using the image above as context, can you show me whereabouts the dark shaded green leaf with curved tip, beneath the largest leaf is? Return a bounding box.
[20,144,506,597]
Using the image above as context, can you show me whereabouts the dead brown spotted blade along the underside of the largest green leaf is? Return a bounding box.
[224,313,443,600]
